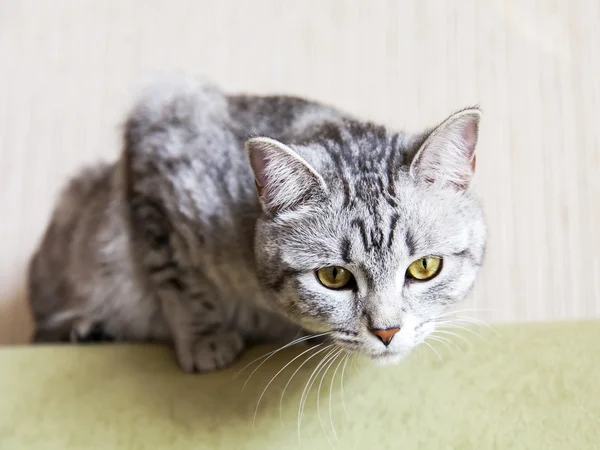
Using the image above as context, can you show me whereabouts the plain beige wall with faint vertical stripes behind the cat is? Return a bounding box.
[0,0,600,343]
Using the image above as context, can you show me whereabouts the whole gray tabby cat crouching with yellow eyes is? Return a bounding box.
[29,79,486,372]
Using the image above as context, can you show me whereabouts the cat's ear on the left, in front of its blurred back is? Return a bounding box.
[246,137,327,214]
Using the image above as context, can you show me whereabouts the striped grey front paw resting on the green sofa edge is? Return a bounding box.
[177,331,244,373]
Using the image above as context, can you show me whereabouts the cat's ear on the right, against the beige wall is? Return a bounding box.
[410,108,481,190]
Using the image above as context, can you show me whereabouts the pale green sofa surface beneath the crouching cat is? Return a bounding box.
[0,321,600,450]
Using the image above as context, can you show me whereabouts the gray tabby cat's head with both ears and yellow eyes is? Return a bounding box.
[246,109,486,362]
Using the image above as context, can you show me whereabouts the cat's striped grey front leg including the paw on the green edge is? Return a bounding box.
[132,199,244,372]
